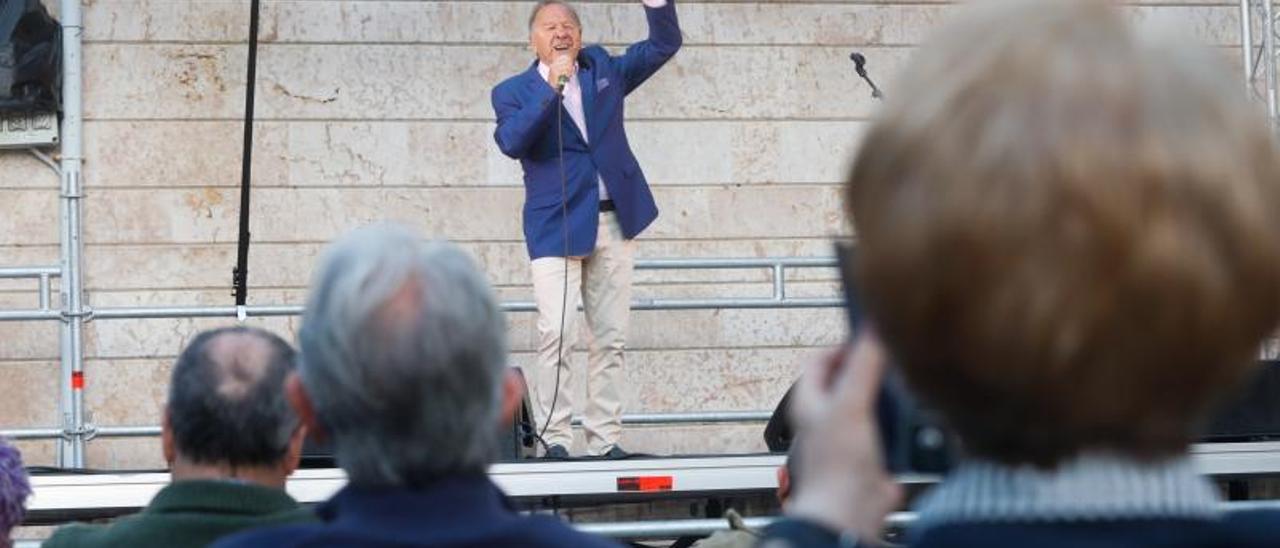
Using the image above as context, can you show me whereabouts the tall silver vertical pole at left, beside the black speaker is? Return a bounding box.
[58,0,84,469]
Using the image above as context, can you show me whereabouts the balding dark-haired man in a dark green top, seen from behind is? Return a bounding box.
[44,326,315,548]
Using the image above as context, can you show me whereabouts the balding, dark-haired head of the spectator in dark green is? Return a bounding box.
[166,326,298,466]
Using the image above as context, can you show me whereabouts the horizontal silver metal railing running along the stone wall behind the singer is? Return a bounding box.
[0,257,844,448]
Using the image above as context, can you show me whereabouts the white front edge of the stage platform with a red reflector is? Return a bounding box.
[28,442,1280,524]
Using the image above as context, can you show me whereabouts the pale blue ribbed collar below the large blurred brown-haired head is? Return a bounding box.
[916,453,1221,529]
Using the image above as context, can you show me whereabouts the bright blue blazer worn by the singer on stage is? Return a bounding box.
[493,0,681,259]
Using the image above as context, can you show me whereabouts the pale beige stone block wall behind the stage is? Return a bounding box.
[0,0,1239,469]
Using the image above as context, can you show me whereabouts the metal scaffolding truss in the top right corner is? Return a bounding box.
[1240,0,1280,129]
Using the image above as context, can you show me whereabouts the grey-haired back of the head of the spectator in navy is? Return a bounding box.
[300,225,507,487]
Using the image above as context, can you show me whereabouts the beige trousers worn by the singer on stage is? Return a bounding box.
[525,211,635,455]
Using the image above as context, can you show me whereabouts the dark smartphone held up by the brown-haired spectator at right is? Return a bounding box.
[828,242,955,474]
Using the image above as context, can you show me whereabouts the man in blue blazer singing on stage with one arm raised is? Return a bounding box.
[493,0,681,458]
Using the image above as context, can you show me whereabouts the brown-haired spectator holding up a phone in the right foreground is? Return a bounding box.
[763,0,1280,548]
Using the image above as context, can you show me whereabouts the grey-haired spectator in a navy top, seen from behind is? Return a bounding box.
[218,225,613,548]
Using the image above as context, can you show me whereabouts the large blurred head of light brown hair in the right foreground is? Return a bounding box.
[846,0,1280,466]
